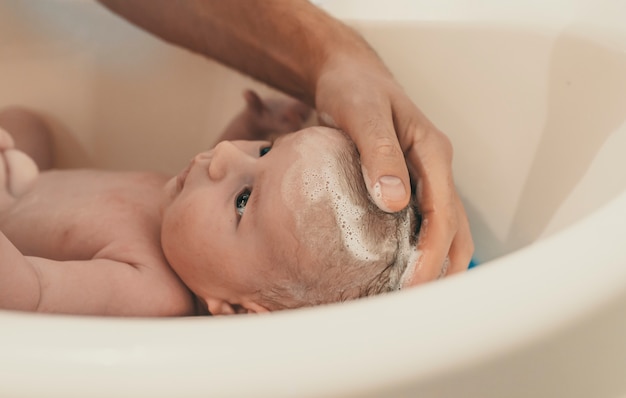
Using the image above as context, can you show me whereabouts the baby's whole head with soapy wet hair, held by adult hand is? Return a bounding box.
[162,127,419,314]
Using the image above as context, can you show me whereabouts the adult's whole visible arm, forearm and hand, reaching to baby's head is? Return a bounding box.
[99,0,473,284]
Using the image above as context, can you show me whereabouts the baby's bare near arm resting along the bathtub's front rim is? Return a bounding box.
[0,232,193,316]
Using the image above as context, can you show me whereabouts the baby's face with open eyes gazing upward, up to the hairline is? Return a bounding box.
[161,127,347,310]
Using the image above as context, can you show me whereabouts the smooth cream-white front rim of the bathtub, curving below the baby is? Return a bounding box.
[0,188,626,396]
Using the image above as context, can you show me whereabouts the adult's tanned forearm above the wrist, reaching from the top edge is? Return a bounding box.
[99,0,371,105]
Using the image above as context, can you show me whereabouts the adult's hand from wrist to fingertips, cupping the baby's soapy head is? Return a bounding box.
[315,53,474,285]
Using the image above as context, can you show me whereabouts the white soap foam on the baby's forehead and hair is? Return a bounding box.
[281,129,379,261]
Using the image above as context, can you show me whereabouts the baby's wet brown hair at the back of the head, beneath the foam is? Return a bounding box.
[260,132,421,310]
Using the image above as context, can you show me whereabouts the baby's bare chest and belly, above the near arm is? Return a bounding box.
[0,172,160,260]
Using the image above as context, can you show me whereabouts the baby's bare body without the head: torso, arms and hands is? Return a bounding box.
[0,93,302,316]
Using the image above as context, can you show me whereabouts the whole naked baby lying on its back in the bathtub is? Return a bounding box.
[0,92,419,316]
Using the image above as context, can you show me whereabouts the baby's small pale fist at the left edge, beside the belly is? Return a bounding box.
[0,127,39,198]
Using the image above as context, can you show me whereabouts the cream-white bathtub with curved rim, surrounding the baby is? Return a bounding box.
[0,0,626,398]
